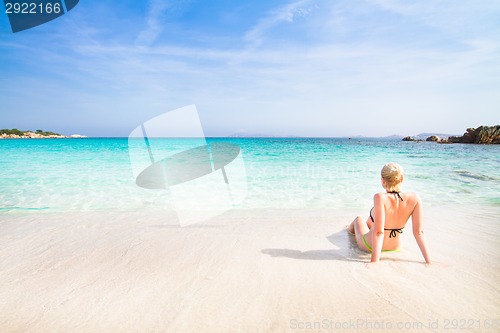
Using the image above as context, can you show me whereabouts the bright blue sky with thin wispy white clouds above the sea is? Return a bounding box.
[0,0,500,136]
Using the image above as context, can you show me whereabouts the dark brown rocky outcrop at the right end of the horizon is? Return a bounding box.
[403,125,500,144]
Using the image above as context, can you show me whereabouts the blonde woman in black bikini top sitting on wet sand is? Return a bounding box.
[348,162,431,264]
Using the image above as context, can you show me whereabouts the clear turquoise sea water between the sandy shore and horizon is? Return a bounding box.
[0,138,500,219]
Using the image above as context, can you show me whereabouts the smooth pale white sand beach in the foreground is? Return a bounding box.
[0,207,500,332]
